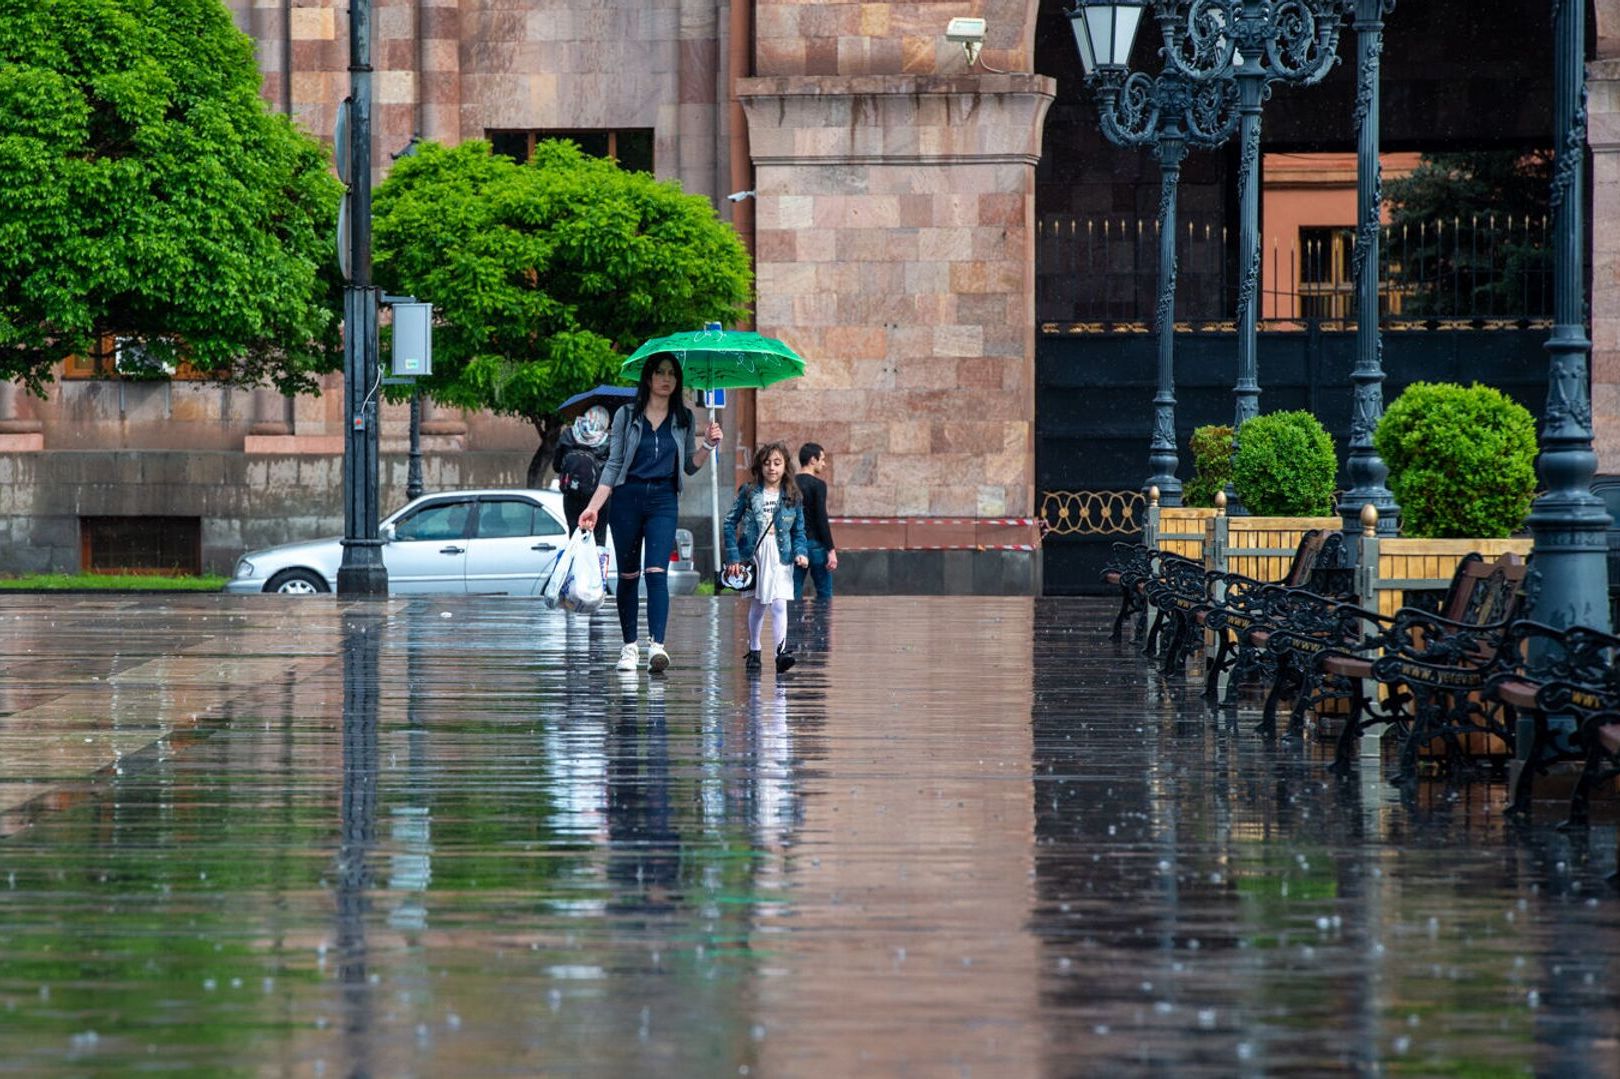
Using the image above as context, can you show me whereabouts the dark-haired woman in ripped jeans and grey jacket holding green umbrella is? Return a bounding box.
[580,352,721,674]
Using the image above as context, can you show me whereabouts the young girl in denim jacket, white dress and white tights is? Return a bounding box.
[724,442,810,674]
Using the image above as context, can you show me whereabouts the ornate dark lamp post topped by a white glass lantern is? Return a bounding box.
[1068,0,1238,505]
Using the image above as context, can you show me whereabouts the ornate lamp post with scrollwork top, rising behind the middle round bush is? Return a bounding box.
[1155,0,1353,514]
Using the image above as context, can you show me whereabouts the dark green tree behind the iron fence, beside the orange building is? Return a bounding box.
[1383,151,1552,318]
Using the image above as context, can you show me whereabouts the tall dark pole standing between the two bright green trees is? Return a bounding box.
[337,0,389,596]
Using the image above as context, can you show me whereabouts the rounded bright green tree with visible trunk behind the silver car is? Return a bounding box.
[373,141,752,486]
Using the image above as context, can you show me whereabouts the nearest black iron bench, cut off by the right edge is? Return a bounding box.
[1486,619,1620,826]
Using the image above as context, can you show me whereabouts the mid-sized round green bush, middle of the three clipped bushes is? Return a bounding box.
[1231,412,1338,517]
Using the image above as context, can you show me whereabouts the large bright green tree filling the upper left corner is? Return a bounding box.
[0,0,342,392]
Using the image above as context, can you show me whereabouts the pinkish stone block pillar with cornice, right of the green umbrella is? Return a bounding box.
[737,73,1055,549]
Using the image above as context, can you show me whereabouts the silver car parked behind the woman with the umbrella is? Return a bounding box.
[225,489,698,596]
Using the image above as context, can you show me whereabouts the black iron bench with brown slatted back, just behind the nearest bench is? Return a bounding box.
[1296,554,1528,783]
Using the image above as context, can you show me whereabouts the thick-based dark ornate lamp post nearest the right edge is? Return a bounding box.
[1526,0,1609,630]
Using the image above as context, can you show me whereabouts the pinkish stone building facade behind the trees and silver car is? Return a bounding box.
[9,0,1620,591]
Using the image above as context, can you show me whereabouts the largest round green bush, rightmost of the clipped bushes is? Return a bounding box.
[1372,382,1536,540]
